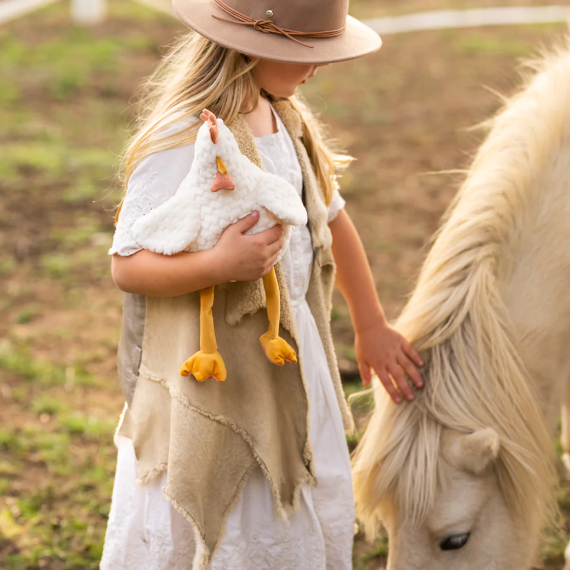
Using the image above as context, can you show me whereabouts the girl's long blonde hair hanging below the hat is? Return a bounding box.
[116,31,352,220]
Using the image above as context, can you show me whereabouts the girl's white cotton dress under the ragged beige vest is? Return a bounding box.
[100,106,354,570]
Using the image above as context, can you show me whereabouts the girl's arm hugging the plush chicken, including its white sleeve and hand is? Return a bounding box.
[111,118,283,297]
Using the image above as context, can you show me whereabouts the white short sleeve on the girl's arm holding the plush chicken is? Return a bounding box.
[109,123,194,255]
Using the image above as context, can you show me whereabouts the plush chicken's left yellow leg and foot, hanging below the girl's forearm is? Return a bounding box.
[180,286,227,382]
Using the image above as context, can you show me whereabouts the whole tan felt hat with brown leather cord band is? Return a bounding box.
[172,0,382,64]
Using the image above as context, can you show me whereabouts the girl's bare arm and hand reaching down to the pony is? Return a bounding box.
[329,209,423,403]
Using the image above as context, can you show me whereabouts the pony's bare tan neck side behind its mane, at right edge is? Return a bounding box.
[499,145,570,430]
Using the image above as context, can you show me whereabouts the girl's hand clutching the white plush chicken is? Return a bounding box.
[212,211,283,283]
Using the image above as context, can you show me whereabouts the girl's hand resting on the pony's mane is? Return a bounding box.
[354,322,424,404]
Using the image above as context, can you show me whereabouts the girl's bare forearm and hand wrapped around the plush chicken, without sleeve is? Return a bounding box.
[112,212,283,297]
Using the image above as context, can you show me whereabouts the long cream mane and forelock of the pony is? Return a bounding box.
[353,38,570,536]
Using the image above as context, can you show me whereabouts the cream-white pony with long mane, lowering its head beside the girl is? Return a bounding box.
[354,39,570,570]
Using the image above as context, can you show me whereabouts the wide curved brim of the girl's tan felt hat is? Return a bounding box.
[172,0,382,64]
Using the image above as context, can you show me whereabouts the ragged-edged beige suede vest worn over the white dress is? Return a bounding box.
[113,100,353,570]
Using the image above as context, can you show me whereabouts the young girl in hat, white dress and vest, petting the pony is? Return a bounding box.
[101,0,422,570]
